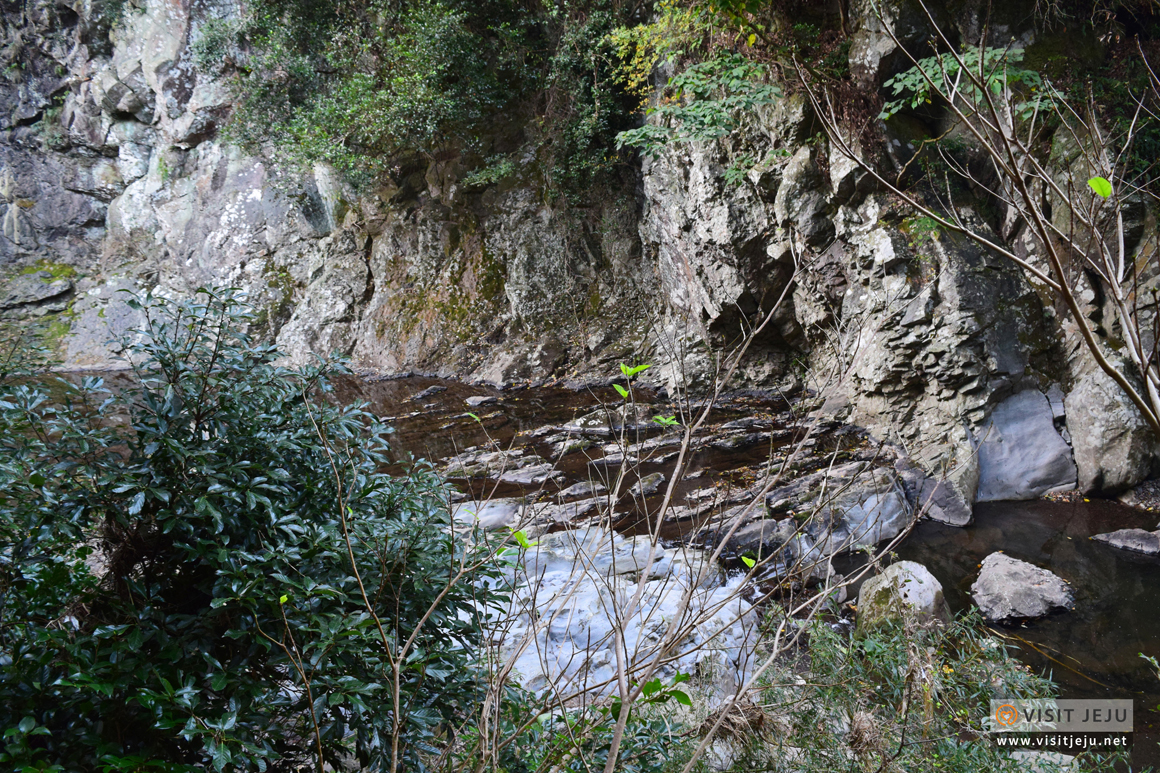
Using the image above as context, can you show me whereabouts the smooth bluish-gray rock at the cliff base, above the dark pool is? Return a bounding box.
[976,389,1075,501]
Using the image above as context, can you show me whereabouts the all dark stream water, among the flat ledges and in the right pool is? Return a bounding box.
[336,377,1160,767]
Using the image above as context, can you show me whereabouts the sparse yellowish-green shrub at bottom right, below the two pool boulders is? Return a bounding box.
[705,612,1126,773]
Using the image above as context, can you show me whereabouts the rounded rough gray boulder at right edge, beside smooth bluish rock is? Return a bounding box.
[1064,370,1160,494]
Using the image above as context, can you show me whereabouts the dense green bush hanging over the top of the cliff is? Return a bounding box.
[206,0,633,193]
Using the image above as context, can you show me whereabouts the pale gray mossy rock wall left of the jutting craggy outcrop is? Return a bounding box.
[0,0,655,381]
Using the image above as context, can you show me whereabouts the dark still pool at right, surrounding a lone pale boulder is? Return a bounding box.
[898,499,1160,768]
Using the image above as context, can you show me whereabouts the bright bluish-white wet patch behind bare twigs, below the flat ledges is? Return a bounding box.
[496,527,756,695]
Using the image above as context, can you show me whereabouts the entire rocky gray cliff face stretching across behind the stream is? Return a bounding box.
[0,0,1157,506]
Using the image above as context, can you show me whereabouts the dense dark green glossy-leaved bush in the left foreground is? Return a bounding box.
[0,292,495,771]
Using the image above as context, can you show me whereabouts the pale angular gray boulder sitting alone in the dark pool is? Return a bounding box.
[971,552,1073,622]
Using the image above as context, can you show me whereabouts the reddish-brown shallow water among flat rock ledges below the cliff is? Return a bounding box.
[335,377,812,529]
